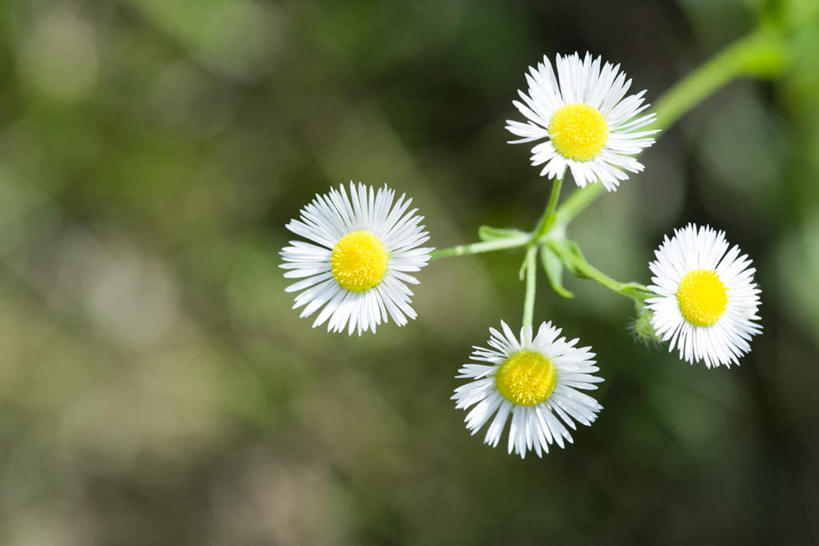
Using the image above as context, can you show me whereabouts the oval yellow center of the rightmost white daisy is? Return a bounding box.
[677,269,728,326]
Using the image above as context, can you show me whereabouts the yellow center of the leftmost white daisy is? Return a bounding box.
[330,230,390,292]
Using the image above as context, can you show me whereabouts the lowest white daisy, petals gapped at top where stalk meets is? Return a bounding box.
[452,321,603,458]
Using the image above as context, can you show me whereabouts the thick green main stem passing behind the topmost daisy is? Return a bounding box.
[555,29,782,226]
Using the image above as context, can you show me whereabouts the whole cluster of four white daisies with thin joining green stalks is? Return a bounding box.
[281,53,762,457]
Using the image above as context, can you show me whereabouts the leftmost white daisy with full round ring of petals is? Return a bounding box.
[281,182,432,335]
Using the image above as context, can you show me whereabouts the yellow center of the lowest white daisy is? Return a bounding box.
[495,351,556,406]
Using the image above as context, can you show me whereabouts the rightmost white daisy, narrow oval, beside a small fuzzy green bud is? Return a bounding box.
[646,224,762,368]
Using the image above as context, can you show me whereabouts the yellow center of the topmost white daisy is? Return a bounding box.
[549,102,609,161]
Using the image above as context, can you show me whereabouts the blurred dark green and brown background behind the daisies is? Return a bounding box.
[0,0,819,546]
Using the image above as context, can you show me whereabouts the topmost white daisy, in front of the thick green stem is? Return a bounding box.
[506,53,657,191]
